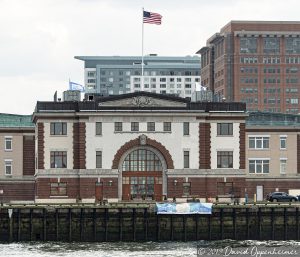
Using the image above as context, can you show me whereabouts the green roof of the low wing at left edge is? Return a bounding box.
[0,113,35,128]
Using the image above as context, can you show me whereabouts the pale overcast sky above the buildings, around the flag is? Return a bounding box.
[0,0,300,114]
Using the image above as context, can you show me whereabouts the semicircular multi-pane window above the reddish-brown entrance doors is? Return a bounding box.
[122,149,163,171]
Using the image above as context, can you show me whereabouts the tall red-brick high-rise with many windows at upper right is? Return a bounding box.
[197,21,300,113]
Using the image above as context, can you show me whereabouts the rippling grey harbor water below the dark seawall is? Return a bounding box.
[0,240,300,257]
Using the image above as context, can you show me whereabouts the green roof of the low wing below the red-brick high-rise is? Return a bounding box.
[246,112,300,128]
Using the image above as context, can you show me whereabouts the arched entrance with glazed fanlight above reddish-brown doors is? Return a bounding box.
[121,147,166,201]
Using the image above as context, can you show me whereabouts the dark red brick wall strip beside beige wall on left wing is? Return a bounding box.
[23,136,35,176]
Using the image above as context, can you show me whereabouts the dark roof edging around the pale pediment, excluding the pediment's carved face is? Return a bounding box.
[35,91,246,112]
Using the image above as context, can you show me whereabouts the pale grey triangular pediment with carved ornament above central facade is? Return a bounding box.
[99,95,186,108]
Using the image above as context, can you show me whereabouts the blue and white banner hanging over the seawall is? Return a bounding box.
[156,203,212,214]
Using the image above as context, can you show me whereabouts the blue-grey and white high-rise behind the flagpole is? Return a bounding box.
[75,55,200,97]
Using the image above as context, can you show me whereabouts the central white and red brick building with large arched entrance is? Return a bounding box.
[33,92,247,202]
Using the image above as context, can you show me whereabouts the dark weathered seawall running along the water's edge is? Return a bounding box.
[0,204,300,242]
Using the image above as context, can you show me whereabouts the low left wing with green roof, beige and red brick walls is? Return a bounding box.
[0,113,35,202]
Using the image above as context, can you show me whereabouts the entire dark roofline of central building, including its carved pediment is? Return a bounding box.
[35,91,246,113]
